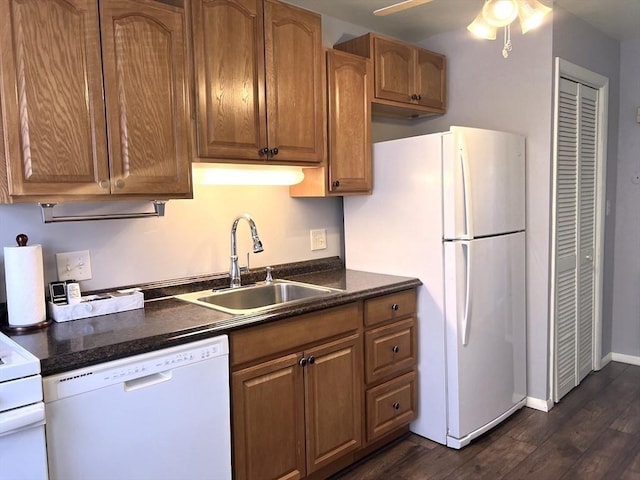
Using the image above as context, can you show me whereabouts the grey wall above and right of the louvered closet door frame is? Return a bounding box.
[553,5,624,356]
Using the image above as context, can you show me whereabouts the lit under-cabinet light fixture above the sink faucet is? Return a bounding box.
[192,163,304,185]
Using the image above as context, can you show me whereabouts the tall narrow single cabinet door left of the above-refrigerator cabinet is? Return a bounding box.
[327,50,372,193]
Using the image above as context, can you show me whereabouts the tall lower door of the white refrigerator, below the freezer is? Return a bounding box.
[444,232,526,438]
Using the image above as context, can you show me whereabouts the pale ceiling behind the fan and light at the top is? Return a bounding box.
[286,0,640,42]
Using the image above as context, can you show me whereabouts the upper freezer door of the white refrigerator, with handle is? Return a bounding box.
[442,127,525,239]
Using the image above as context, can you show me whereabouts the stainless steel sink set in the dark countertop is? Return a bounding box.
[175,280,341,315]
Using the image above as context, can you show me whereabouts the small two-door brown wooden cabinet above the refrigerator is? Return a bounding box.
[334,33,446,117]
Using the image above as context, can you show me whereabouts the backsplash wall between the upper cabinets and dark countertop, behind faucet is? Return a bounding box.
[0,181,342,300]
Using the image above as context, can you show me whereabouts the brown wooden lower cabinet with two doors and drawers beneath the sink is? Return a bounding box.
[229,290,417,480]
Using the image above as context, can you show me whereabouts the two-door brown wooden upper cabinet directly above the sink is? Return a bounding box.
[192,0,325,165]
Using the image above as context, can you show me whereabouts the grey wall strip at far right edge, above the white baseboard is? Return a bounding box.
[612,40,640,357]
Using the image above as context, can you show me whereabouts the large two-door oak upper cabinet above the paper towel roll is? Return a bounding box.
[0,0,192,202]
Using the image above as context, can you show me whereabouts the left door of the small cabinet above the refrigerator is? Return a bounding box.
[373,37,416,103]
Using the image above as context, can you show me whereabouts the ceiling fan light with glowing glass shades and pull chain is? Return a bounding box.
[467,0,551,58]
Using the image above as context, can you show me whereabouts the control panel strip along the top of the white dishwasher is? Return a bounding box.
[43,335,229,403]
